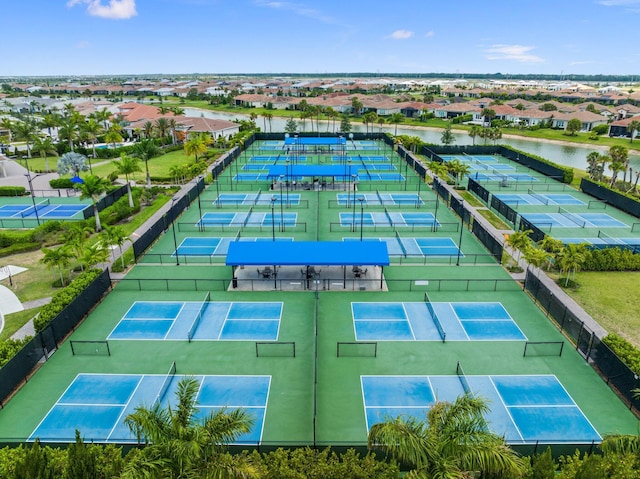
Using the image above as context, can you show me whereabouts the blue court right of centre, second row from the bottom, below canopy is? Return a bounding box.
[351,302,527,341]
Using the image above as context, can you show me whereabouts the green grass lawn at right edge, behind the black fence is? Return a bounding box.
[549,271,640,348]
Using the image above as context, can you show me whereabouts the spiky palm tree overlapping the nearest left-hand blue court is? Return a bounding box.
[124,377,256,478]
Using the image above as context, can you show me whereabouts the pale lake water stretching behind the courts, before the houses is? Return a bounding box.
[185,108,640,171]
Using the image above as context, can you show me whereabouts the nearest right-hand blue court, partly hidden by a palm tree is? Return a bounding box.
[360,375,602,444]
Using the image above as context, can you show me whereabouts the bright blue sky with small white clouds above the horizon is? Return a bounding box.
[5,0,640,76]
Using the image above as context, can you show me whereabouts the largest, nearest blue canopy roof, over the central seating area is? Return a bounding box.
[226,240,389,266]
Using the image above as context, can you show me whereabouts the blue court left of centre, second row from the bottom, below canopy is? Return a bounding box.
[107,301,283,341]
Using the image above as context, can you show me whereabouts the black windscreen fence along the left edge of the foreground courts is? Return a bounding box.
[0,270,111,408]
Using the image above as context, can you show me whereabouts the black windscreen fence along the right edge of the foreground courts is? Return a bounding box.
[525,271,640,415]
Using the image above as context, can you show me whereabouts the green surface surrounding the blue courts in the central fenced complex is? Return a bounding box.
[0,142,637,447]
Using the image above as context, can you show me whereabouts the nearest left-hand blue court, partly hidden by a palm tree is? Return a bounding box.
[29,374,271,444]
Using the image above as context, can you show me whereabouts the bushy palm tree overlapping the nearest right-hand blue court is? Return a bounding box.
[368,394,527,479]
